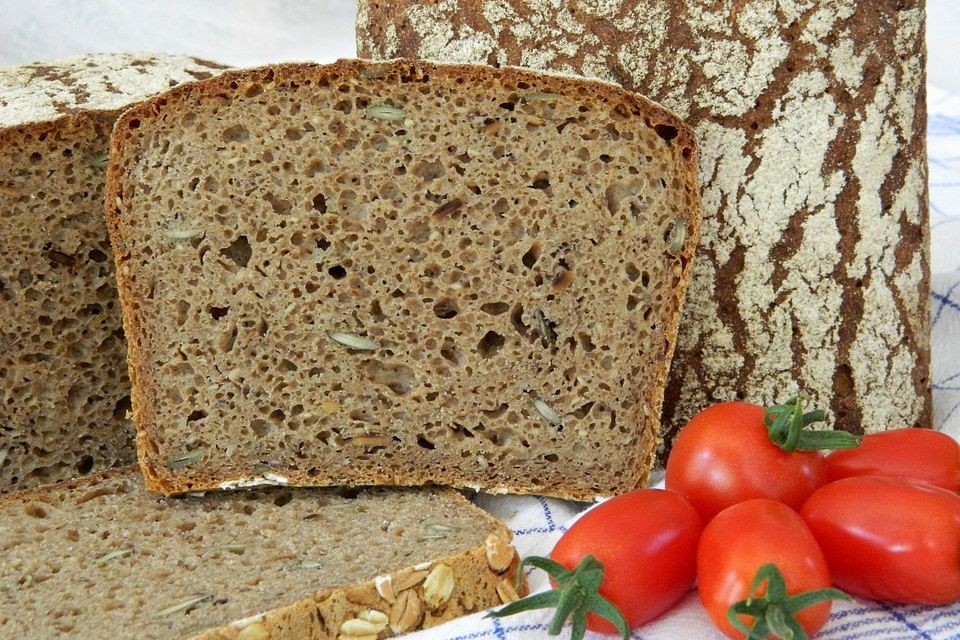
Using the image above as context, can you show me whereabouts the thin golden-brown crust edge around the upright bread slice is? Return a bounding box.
[105,60,701,500]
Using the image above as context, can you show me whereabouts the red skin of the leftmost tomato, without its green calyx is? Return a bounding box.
[550,489,703,633]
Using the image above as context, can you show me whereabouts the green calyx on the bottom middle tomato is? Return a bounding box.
[727,564,851,640]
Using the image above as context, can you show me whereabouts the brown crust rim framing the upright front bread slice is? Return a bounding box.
[106,60,700,499]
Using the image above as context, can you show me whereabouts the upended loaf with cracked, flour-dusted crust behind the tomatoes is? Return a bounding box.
[357,0,931,448]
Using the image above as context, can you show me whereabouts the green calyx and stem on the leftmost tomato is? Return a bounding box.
[487,556,630,640]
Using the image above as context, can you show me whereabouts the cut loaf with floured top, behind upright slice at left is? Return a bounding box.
[0,54,222,491]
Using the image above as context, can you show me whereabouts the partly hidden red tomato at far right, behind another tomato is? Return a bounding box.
[825,429,960,491]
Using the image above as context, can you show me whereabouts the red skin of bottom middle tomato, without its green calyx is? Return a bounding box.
[697,498,831,640]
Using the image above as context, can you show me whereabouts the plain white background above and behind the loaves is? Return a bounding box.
[0,0,960,93]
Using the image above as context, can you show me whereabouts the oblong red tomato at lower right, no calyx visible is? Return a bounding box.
[801,477,960,605]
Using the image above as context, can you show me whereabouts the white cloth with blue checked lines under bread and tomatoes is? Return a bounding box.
[407,87,960,640]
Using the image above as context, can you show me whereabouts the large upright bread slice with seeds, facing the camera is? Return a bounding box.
[107,60,699,499]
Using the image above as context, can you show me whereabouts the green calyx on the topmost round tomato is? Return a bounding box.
[763,393,860,453]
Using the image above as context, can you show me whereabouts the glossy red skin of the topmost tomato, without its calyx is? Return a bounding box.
[666,402,826,522]
